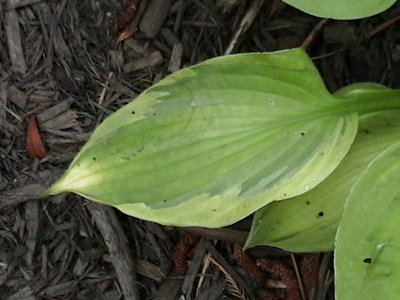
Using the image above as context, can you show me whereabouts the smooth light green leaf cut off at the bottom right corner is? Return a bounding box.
[335,143,400,300]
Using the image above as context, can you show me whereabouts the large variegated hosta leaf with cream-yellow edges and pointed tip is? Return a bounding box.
[47,49,357,227]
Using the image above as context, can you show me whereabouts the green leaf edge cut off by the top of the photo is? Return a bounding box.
[283,0,396,20]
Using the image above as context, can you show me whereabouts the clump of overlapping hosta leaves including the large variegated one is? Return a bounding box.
[46,47,400,300]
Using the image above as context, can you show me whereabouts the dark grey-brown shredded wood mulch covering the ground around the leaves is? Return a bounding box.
[0,0,400,300]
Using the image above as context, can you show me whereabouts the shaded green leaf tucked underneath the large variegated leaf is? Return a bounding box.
[246,109,400,252]
